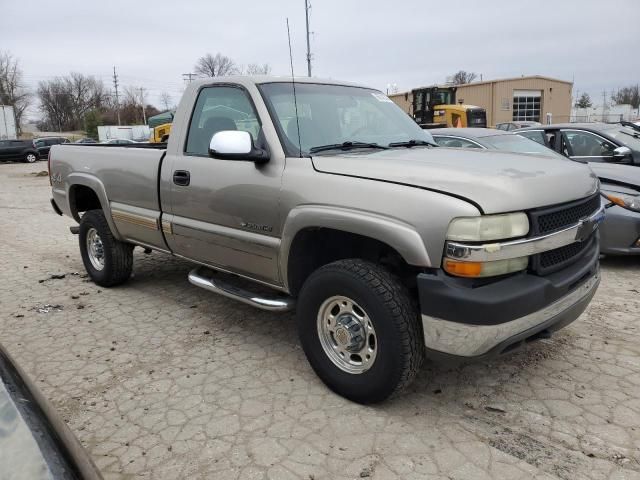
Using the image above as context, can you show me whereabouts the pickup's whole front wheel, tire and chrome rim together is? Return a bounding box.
[297,259,424,403]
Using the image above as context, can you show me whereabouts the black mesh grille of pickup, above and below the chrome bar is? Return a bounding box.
[529,193,600,275]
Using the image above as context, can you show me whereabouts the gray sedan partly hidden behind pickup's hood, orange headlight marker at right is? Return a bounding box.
[433,128,640,255]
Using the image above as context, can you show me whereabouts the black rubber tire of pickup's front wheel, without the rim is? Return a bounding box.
[297,259,424,403]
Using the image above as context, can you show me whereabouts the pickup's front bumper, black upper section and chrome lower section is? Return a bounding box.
[418,242,600,359]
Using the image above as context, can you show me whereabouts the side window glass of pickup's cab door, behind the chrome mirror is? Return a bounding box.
[185,86,261,156]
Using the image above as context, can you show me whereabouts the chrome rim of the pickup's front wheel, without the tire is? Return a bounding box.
[317,296,378,374]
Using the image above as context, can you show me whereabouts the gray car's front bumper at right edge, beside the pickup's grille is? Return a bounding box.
[600,205,640,255]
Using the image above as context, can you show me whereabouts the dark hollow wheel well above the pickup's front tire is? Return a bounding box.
[286,227,422,296]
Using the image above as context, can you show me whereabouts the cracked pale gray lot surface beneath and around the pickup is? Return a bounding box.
[0,162,640,480]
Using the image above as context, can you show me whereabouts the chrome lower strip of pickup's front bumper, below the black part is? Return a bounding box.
[422,272,600,357]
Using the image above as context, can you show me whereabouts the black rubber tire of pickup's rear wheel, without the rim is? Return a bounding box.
[78,210,133,287]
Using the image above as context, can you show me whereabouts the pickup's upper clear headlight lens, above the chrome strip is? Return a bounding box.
[447,212,529,242]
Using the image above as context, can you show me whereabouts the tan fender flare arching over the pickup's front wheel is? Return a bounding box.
[280,205,431,290]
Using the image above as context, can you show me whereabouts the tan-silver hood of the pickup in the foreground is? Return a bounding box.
[312,147,600,213]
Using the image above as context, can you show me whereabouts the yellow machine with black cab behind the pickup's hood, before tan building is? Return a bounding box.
[411,85,487,128]
